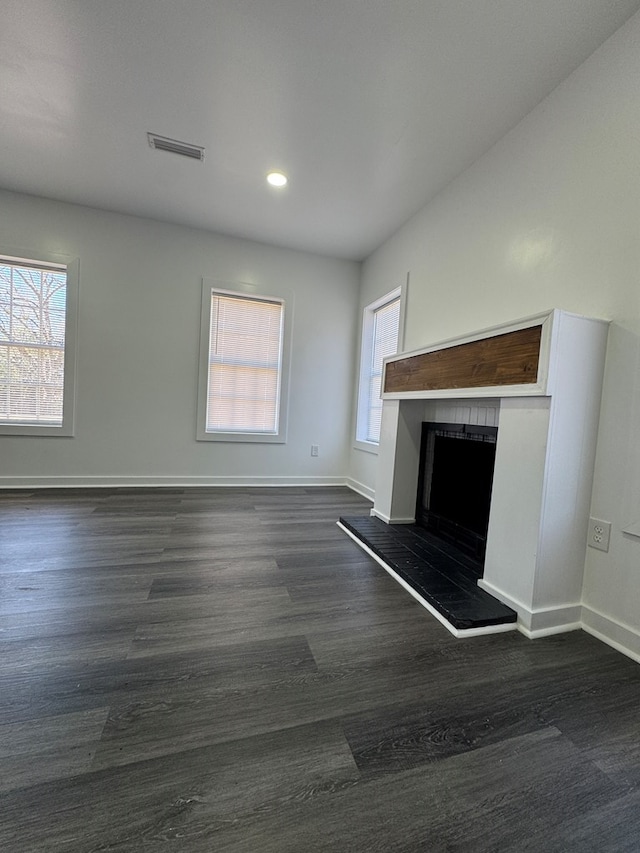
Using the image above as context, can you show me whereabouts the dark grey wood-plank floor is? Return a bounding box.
[0,488,640,853]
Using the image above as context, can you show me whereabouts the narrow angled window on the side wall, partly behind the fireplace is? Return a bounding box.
[356,288,402,449]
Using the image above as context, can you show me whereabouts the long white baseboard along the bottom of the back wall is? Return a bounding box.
[0,475,351,489]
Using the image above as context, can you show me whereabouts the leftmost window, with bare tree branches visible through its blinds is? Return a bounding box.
[0,257,77,436]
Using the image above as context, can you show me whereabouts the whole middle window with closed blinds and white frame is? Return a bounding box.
[197,283,289,442]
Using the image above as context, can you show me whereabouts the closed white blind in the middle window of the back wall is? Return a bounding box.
[206,291,284,435]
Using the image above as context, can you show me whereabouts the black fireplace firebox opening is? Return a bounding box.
[416,423,498,573]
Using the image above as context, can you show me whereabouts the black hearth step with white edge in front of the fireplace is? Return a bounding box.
[340,516,517,631]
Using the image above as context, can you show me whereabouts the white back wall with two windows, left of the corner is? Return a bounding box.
[0,193,359,486]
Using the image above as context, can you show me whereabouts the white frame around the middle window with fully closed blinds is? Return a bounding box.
[196,278,293,444]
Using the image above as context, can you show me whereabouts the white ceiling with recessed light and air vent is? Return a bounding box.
[0,0,640,260]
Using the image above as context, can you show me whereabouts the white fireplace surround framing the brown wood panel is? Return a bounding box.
[371,309,608,637]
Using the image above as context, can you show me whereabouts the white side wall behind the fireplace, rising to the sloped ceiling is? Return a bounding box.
[351,10,640,654]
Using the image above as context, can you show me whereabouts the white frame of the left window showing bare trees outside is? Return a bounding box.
[0,252,80,438]
